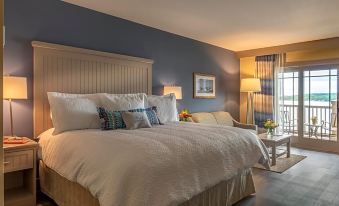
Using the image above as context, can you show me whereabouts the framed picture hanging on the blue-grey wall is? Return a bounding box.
[193,73,215,99]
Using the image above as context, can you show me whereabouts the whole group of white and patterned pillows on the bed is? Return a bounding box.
[47,92,178,134]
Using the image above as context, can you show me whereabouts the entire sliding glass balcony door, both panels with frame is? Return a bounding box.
[279,65,339,152]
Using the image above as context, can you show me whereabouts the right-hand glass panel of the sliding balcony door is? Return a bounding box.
[303,68,338,142]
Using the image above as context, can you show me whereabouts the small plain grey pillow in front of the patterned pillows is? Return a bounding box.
[122,112,151,129]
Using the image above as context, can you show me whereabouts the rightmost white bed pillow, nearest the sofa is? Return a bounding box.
[147,94,179,123]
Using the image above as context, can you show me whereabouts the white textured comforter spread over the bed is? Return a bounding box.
[40,123,268,206]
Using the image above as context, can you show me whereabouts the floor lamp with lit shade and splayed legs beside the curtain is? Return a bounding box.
[240,78,261,124]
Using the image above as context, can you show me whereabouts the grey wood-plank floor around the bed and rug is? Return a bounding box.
[38,148,339,206]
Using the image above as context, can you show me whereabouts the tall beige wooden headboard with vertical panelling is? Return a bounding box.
[32,41,153,137]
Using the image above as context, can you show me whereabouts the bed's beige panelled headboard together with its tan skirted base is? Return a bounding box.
[32,41,255,206]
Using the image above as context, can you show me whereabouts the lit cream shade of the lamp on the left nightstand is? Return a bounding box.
[3,76,27,99]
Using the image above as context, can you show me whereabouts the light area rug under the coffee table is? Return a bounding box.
[254,154,306,173]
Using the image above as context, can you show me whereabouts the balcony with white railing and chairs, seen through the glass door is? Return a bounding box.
[280,101,337,142]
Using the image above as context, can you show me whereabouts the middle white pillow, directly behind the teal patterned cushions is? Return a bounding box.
[101,93,146,111]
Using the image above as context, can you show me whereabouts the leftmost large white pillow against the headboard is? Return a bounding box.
[47,92,103,134]
